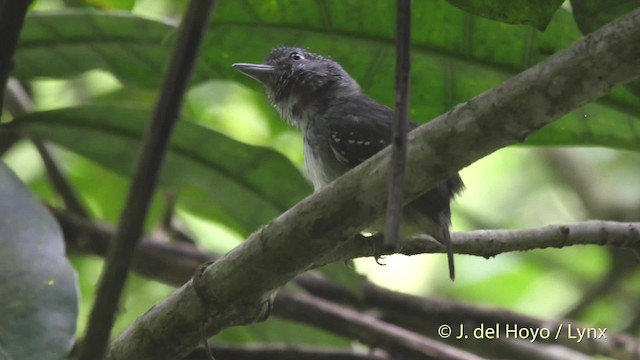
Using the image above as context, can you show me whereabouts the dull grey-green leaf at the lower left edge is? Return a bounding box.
[0,163,78,360]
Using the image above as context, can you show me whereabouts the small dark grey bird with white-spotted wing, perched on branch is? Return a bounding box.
[233,47,464,280]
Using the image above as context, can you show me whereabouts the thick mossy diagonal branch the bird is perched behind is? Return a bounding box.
[109,10,640,359]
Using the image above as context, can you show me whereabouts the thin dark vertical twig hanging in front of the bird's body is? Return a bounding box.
[384,0,411,251]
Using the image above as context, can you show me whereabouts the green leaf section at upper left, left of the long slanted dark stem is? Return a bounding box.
[13,9,184,87]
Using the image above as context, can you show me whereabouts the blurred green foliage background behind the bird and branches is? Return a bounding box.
[0,0,640,356]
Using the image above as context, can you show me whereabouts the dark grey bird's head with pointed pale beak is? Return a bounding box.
[233,47,360,125]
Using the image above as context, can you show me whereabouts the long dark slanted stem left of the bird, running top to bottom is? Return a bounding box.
[79,0,215,360]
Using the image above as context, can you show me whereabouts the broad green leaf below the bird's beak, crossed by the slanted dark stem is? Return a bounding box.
[12,106,312,235]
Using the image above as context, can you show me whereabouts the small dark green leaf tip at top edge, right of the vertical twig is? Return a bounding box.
[447,0,564,31]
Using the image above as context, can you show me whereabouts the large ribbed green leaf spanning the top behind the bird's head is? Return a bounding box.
[15,0,640,149]
